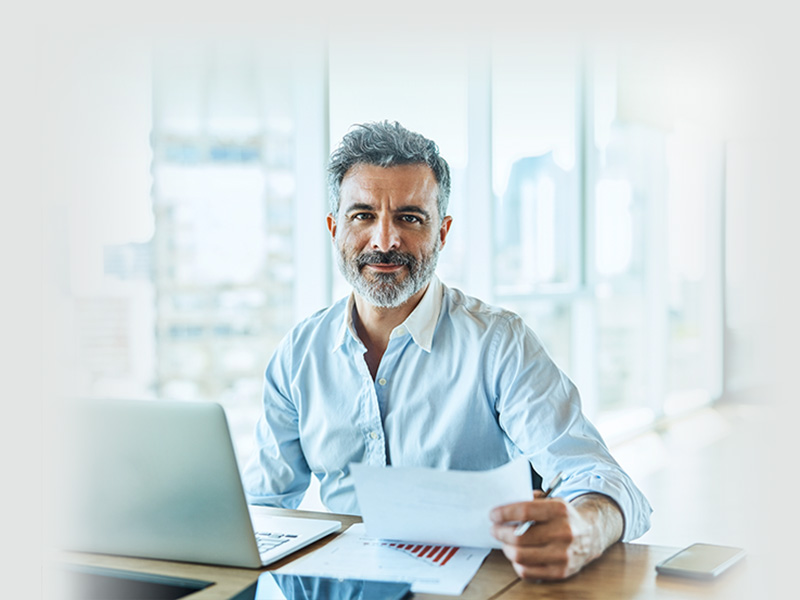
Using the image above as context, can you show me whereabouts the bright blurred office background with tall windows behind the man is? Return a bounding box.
[40,31,792,572]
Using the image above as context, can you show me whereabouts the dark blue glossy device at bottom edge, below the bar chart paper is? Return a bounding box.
[255,571,411,600]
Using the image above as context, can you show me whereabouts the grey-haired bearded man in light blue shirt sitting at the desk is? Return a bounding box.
[245,122,651,579]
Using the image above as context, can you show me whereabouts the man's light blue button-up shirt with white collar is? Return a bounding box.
[244,277,652,540]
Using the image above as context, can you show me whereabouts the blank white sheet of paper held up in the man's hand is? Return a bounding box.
[350,458,533,548]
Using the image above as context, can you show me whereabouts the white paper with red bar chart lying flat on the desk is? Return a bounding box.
[276,523,489,596]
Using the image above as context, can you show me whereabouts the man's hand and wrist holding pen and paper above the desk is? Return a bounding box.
[490,491,623,580]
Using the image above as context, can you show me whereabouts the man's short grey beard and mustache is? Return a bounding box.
[335,243,439,308]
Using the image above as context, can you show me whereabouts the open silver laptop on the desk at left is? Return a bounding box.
[56,400,341,568]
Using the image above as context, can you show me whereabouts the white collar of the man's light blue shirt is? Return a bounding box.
[333,275,444,352]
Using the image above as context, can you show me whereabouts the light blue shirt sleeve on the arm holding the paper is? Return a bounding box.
[492,317,652,541]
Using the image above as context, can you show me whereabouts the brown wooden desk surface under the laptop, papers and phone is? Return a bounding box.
[53,509,763,600]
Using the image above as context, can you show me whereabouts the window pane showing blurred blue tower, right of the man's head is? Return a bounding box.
[485,38,580,300]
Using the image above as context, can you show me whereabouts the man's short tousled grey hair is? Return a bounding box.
[328,121,450,219]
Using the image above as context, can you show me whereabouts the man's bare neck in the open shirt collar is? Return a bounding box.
[353,284,430,378]
